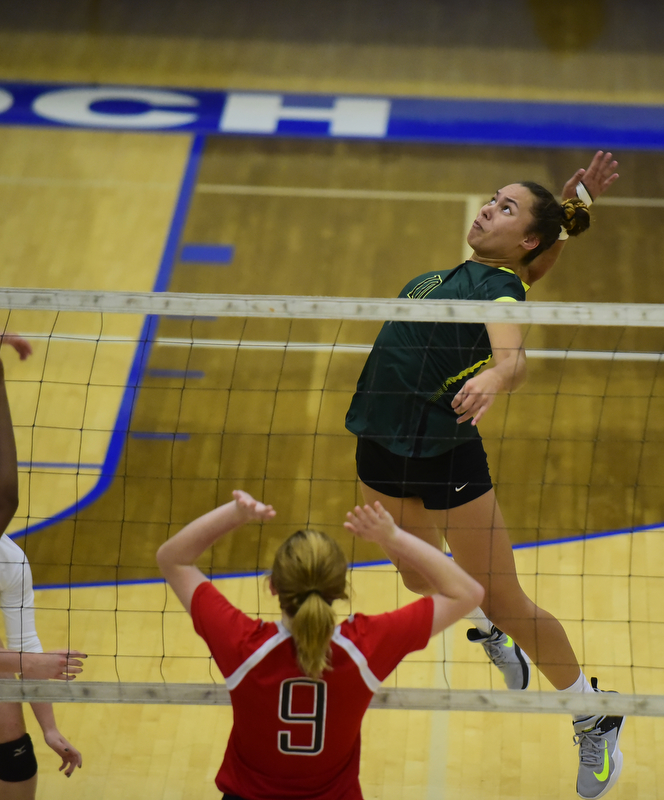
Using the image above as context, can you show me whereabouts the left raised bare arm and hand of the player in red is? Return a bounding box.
[157,491,276,613]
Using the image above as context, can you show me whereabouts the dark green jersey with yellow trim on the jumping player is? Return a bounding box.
[346,261,528,458]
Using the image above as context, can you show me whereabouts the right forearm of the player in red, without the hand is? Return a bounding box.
[383,528,484,609]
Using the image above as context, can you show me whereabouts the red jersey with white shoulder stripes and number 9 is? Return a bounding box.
[191,582,433,800]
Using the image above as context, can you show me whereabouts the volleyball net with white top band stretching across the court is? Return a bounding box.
[0,289,664,716]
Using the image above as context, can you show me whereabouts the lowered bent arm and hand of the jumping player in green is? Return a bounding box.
[452,322,526,425]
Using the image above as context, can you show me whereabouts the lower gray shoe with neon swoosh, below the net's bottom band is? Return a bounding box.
[574,678,625,800]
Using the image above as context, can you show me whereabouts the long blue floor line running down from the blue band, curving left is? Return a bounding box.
[9,136,206,540]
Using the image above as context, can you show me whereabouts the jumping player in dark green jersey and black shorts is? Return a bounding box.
[346,151,623,799]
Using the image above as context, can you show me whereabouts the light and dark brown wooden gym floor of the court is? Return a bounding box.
[0,0,664,800]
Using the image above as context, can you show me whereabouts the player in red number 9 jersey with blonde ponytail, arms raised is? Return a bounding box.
[157,491,484,800]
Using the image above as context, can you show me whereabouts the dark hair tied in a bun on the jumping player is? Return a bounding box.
[521,181,590,264]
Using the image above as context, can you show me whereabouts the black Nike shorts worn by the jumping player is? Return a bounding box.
[355,436,492,510]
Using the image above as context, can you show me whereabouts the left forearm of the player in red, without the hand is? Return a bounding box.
[157,500,246,570]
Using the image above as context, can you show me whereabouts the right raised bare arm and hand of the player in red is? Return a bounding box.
[344,501,484,636]
